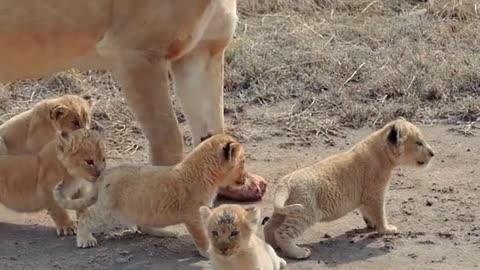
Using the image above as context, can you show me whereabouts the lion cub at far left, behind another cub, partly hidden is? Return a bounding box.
[0,95,95,155]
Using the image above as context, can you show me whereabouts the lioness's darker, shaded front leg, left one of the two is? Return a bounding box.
[113,56,183,165]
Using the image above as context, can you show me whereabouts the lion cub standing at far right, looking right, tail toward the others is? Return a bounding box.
[264,118,433,259]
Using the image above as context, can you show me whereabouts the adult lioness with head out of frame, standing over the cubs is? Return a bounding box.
[0,0,265,200]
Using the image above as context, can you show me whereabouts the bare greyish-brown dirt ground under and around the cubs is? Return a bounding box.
[0,117,480,270]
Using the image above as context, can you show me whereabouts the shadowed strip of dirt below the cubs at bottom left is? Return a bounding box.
[0,222,208,270]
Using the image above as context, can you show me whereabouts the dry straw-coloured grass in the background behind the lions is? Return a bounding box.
[0,0,480,152]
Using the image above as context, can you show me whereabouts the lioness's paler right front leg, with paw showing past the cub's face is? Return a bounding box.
[172,46,266,201]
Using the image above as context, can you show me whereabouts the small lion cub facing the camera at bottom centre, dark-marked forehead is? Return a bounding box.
[199,204,287,270]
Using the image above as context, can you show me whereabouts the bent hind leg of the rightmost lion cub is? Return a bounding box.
[275,212,314,259]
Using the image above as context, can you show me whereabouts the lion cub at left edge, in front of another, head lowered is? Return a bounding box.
[0,129,105,235]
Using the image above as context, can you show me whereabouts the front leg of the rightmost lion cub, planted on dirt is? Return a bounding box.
[361,195,397,234]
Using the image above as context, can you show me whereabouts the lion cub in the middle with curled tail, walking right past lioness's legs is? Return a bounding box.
[54,134,245,256]
